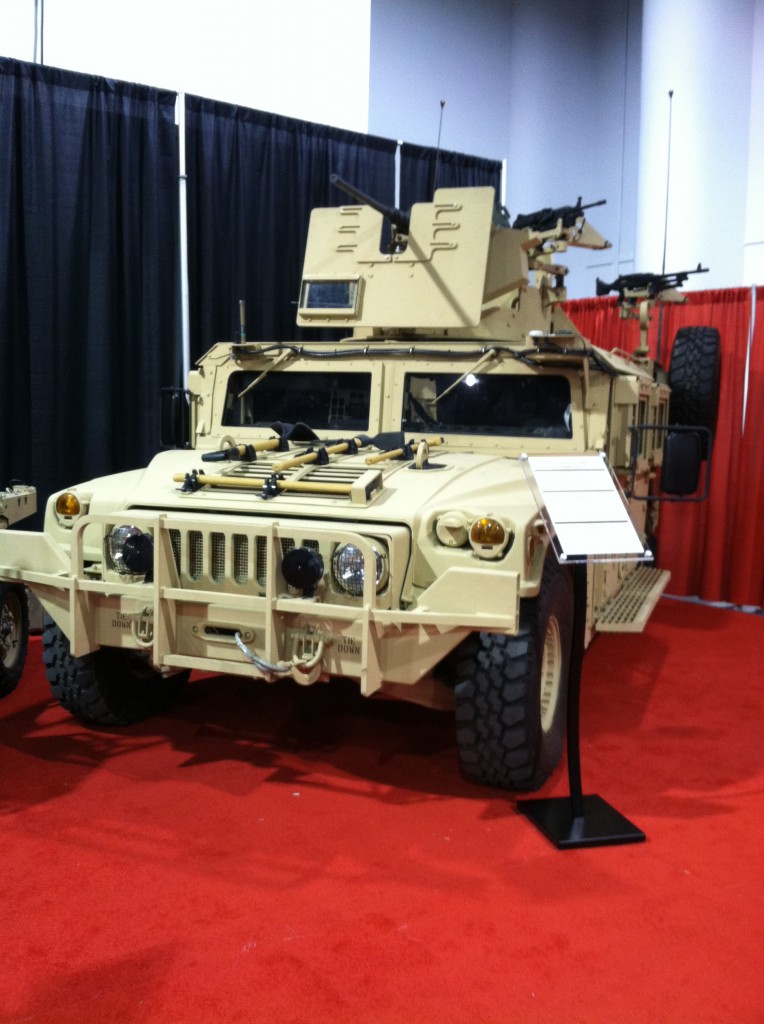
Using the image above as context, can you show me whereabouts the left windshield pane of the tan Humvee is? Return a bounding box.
[223,371,372,432]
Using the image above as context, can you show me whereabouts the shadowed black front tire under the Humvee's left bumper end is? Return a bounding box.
[42,617,189,726]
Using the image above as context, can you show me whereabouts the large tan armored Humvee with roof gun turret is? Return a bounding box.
[0,180,716,790]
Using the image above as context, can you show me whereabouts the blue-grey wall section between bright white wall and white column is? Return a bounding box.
[369,0,641,297]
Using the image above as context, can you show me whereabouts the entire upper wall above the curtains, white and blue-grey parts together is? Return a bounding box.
[0,0,764,297]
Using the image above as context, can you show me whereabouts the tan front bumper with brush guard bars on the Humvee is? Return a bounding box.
[0,511,519,694]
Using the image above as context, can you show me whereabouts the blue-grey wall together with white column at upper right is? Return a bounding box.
[369,0,764,297]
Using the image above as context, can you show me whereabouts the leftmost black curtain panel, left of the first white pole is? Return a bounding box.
[0,58,180,524]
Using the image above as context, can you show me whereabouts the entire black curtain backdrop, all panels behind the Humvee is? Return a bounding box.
[0,57,501,525]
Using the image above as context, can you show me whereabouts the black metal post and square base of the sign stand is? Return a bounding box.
[517,561,645,850]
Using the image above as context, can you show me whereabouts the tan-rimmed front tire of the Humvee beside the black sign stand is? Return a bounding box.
[456,553,574,791]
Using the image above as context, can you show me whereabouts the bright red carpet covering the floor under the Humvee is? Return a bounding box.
[0,600,764,1024]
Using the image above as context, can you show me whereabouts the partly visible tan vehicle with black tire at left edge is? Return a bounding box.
[0,482,37,697]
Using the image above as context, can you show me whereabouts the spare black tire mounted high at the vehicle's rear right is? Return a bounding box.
[669,327,721,459]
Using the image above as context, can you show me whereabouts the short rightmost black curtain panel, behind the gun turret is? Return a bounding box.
[400,142,502,210]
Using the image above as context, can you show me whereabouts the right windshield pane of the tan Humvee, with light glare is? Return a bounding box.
[401,374,572,438]
